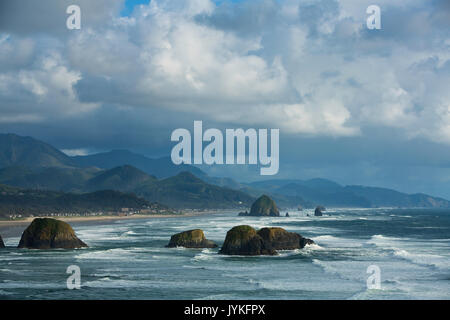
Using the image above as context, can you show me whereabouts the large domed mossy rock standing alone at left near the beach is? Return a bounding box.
[18,218,87,249]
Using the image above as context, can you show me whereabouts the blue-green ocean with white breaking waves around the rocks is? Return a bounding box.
[0,209,450,300]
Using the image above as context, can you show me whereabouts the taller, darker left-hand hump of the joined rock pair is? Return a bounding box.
[219,225,277,256]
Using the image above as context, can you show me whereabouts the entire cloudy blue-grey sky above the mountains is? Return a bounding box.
[0,0,450,198]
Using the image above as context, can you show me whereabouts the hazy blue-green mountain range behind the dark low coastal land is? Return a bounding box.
[0,134,450,209]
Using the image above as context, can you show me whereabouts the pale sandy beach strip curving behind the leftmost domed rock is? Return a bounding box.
[0,210,221,239]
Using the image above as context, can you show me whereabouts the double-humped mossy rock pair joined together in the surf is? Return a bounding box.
[219,226,314,256]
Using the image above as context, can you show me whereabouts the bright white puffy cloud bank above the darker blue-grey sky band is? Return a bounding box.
[0,0,450,143]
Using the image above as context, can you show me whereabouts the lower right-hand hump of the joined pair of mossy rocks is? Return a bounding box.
[258,228,314,250]
